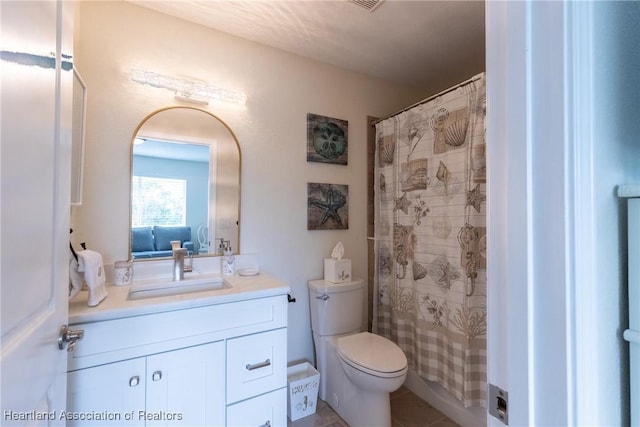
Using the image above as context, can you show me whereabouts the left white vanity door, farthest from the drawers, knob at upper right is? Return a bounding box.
[66,358,145,427]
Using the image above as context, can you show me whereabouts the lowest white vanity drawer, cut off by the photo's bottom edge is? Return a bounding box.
[227,387,287,427]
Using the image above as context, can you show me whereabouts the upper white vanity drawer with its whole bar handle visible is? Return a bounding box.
[227,328,287,403]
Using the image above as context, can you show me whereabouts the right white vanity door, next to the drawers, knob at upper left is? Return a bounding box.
[145,341,225,427]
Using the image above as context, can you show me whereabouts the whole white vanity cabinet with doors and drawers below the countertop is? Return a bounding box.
[67,294,287,427]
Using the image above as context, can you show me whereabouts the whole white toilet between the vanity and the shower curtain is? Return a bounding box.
[308,279,408,427]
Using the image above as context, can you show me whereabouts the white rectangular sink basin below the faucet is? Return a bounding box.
[128,276,231,300]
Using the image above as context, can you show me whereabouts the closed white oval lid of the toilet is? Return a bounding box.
[336,332,407,376]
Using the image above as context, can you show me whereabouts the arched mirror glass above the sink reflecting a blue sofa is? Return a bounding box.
[129,107,241,260]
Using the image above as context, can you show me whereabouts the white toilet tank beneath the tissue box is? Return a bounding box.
[308,279,364,335]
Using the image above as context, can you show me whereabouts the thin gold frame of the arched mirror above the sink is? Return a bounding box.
[127,105,242,262]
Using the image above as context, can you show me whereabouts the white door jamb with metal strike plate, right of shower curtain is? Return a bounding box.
[486,1,531,426]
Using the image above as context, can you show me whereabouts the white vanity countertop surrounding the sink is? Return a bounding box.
[69,272,290,325]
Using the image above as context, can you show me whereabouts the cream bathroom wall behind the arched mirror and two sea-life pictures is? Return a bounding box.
[72,2,422,361]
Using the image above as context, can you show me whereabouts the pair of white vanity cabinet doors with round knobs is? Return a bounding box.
[67,341,225,426]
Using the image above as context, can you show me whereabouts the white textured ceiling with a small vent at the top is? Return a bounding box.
[131,0,485,92]
